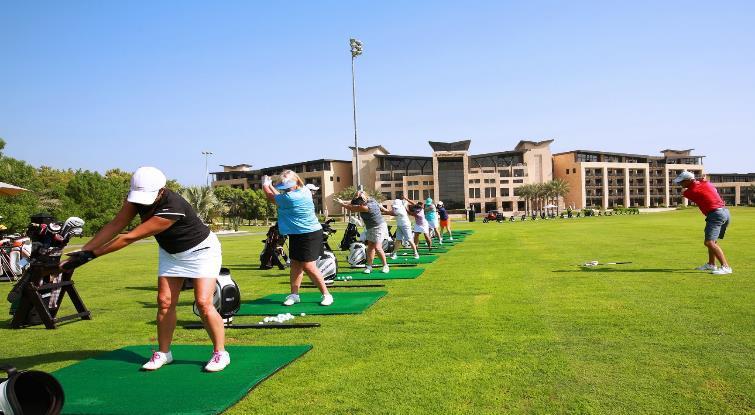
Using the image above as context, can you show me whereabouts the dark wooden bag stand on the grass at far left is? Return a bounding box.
[11,261,92,329]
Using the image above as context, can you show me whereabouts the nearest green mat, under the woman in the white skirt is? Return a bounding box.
[52,344,312,415]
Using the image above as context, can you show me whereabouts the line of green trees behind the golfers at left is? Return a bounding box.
[0,139,275,235]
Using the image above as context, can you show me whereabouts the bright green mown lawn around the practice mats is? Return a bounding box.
[0,208,755,414]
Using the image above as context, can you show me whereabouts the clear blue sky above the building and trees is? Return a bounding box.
[0,1,755,184]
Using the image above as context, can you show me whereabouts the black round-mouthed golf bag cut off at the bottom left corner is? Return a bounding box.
[0,366,65,415]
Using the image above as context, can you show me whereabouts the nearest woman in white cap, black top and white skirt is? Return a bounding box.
[61,167,231,372]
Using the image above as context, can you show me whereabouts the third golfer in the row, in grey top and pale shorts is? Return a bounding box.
[337,190,390,274]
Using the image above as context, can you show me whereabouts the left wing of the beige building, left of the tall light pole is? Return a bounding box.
[212,159,352,215]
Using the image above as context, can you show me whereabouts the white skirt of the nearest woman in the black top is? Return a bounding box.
[157,232,223,278]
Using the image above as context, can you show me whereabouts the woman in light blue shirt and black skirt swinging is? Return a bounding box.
[262,170,333,306]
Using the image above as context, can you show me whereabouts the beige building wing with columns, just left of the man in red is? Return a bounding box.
[553,150,705,209]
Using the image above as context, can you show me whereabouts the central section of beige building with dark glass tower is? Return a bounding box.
[352,140,553,214]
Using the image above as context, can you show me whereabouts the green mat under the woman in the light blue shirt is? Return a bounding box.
[236,291,388,316]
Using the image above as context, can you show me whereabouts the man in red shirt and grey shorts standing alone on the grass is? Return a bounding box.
[674,170,732,275]
